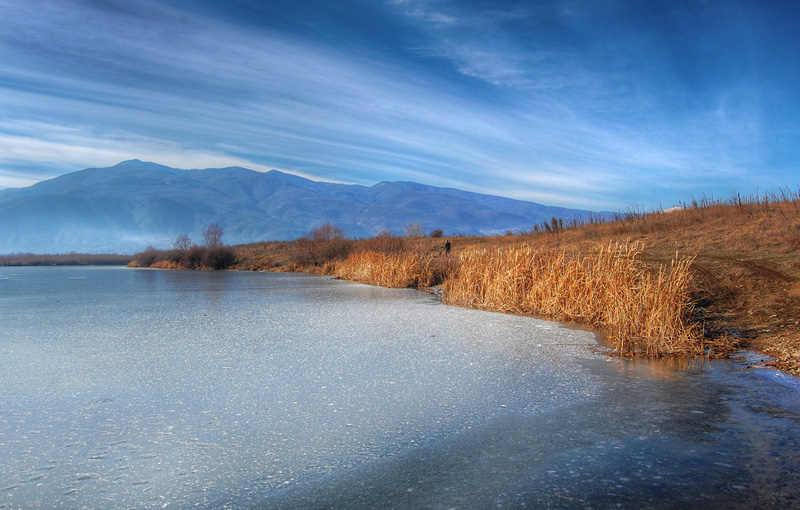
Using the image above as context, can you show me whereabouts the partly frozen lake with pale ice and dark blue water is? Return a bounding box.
[0,267,800,509]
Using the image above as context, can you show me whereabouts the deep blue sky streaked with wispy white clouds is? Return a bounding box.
[0,0,800,211]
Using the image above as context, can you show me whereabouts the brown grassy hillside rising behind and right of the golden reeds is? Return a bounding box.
[236,193,800,374]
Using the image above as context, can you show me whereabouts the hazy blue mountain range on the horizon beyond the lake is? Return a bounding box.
[0,160,608,253]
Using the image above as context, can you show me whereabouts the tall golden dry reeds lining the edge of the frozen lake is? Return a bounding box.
[335,243,703,356]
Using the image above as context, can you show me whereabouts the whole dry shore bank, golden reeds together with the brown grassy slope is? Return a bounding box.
[236,190,800,374]
